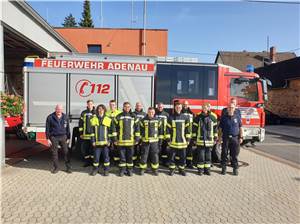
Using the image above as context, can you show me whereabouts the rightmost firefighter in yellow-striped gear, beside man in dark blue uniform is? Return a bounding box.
[193,103,218,176]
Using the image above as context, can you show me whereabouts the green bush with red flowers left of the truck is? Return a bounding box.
[0,93,23,117]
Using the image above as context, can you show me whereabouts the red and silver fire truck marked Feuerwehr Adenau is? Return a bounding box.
[23,53,267,147]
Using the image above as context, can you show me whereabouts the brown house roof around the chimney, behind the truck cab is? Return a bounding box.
[215,51,296,71]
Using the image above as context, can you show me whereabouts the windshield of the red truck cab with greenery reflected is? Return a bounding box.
[230,78,258,101]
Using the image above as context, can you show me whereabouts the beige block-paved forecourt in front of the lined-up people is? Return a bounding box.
[1,146,300,224]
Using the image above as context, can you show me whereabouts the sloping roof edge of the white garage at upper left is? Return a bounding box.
[11,0,77,52]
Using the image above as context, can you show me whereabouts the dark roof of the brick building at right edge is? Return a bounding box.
[255,57,300,88]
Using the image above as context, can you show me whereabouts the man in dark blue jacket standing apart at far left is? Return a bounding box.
[46,105,72,174]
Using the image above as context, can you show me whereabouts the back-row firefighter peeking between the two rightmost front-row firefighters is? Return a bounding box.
[181,100,194,168]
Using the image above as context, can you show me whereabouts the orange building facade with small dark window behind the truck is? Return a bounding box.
[55,28,168,56]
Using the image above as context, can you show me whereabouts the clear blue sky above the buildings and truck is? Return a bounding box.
[28,0,300,62]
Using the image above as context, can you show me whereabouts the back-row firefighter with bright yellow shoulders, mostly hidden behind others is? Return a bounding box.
[105,100,122,164]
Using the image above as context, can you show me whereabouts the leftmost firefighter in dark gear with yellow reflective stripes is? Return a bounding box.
[79,100,95,167]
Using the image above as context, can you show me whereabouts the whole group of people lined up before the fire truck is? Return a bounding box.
[46,99,243,177]
